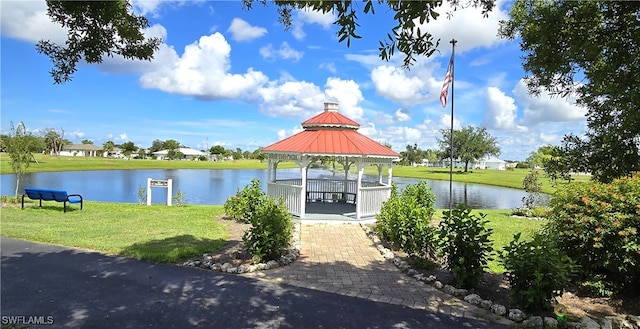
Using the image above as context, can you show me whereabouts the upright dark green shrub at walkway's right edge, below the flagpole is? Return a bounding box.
[438,205,493,288]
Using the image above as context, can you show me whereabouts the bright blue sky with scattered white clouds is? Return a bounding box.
[0,0,586,160]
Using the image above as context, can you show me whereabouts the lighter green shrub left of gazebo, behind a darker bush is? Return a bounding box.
[224,178,267,223]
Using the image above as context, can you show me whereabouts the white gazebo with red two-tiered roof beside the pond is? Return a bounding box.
[262,102,399,220]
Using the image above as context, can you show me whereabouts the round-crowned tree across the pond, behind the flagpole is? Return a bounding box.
[438,126,500,172]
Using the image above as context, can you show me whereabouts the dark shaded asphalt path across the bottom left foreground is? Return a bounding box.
[0,237,508,329]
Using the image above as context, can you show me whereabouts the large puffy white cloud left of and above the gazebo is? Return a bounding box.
[140,32,268,99]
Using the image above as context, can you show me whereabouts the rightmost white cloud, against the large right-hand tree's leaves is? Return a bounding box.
[513,79,587,126]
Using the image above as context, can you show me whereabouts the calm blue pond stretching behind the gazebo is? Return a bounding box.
[0,169,540,209]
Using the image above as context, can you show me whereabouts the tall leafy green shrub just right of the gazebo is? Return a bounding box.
[376,181,435,258]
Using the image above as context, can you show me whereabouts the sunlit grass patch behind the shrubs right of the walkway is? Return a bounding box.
[436,209,546,273]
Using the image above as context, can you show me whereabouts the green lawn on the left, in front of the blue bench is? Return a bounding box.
[0,201,228,263]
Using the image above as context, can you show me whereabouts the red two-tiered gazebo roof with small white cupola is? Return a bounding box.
[262,103,400,158]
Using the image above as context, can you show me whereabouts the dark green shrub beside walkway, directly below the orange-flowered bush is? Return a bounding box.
[500,233,576,311]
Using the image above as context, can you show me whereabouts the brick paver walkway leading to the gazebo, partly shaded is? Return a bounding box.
[244,224,511,324]
